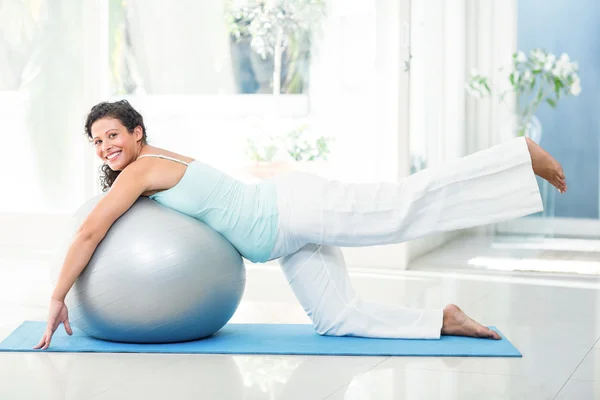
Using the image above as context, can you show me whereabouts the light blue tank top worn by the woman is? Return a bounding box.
[140,154,279,262]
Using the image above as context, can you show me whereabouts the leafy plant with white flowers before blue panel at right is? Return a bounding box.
[466,49,581,142]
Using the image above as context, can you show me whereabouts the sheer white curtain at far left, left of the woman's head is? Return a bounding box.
[0,0,92,211]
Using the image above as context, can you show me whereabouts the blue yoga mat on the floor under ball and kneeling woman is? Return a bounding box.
[0,321,521,357]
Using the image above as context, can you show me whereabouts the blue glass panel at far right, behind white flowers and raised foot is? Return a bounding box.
[498,0,600,239]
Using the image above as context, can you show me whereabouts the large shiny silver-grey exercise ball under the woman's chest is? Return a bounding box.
[58,195,246,343]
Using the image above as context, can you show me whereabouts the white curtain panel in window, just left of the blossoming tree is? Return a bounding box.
[125,0,234,95]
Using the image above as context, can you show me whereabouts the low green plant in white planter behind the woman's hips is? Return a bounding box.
[247,125,333,179]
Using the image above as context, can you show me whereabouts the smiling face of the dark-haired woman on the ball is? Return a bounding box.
[91,117,143,171]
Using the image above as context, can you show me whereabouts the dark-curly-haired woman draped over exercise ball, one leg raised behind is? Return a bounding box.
[35,101,567,349]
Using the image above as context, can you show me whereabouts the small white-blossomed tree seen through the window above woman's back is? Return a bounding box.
[225,0,325,95]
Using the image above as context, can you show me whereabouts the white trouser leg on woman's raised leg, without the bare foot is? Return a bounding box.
[275,138,543,250]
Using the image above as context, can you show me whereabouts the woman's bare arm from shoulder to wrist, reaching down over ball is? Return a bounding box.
[52,163,150,301]
